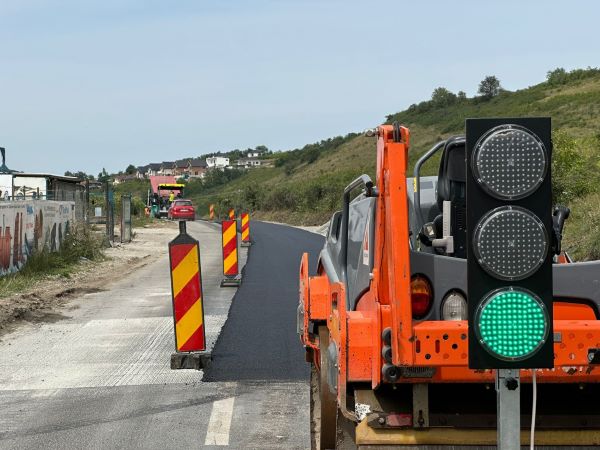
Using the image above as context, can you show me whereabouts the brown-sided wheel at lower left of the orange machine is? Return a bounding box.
[310,326,337,450]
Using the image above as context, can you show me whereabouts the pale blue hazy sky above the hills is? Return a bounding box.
[0,0,600,175]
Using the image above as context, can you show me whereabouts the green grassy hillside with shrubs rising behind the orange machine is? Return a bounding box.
[135,68,600,258]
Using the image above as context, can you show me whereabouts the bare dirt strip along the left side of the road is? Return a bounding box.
[0,221,177,336]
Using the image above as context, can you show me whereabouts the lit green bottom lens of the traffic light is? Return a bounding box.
[475,288,549,361]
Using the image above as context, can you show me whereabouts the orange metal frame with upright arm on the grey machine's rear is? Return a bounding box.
[300,125,600,404]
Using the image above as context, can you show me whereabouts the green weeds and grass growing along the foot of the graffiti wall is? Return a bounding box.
[0,225,104,297]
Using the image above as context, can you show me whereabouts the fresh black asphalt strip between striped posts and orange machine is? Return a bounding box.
[204,222,324,381]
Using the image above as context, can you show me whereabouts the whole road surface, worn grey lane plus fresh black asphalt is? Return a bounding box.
[0,223,322,449]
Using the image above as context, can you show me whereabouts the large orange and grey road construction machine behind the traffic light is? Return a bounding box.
[297,124,600,449]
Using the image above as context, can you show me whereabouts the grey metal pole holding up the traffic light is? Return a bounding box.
[496,369,521,450]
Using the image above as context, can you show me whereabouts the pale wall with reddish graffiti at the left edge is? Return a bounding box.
[0,200,75,276]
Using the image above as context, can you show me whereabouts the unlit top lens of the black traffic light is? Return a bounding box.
[471,125,548,200]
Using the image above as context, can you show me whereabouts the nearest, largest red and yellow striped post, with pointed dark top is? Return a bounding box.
[169,222,210,370]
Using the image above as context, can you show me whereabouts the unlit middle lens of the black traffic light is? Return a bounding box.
[473,206,548,280]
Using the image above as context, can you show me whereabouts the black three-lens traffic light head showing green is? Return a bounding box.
[466,118,554,369]
